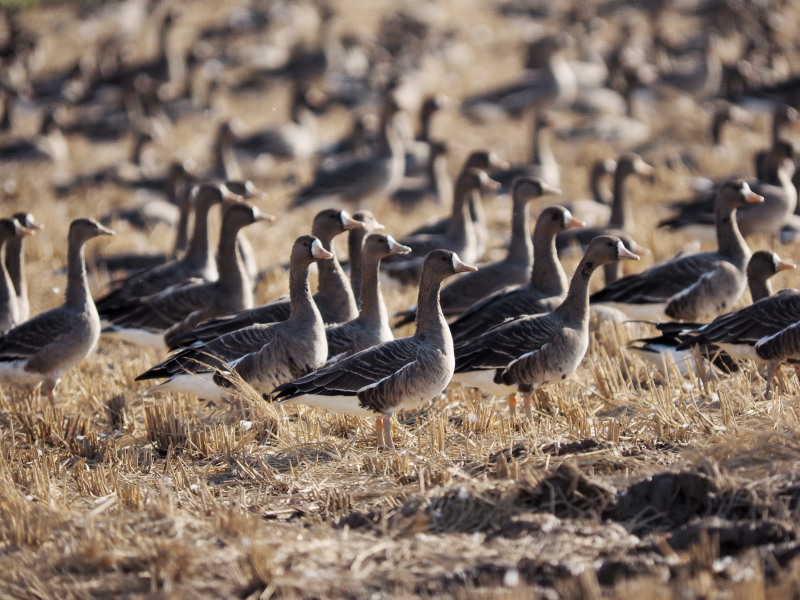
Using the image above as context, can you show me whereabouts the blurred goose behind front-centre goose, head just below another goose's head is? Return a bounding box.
[383,169,500,285]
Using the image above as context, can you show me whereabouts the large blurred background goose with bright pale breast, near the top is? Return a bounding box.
[461,32,578,121]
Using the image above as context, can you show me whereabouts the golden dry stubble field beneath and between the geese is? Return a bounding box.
[0,0,800,599]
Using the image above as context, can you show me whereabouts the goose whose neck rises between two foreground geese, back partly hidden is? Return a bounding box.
[170,208,364,348]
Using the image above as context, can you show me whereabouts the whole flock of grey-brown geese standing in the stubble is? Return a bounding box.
[0,3,800,448]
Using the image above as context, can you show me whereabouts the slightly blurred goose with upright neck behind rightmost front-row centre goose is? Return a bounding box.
[556,153,655,284]
